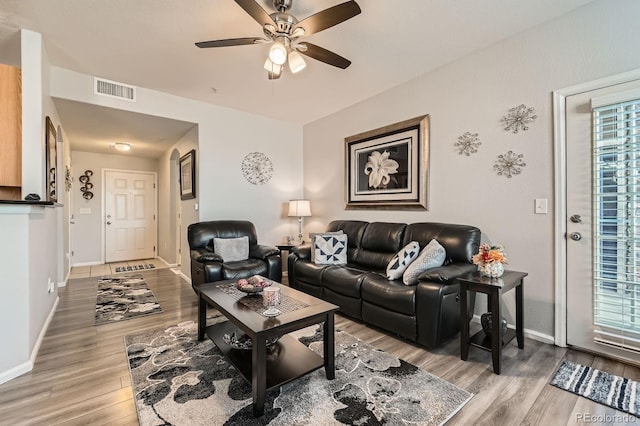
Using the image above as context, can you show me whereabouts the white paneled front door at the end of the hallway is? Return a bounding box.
[104,170,157,262]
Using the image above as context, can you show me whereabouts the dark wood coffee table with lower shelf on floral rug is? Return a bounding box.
[198,281,338,417]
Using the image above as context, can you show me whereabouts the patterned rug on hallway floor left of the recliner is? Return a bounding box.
[95,275,162,325]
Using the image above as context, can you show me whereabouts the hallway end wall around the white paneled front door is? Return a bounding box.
[68,151,158,266]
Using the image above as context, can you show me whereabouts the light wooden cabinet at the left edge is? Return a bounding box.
[0,64,22,200]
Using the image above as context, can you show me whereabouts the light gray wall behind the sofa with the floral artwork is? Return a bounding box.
[304,0,640,339]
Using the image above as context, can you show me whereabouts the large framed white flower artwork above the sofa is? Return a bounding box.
[345,115,429,210]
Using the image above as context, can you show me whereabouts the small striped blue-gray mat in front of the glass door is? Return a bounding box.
[551,361,640,417]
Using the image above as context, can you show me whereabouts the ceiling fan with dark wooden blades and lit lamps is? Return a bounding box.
[196,0,361,80]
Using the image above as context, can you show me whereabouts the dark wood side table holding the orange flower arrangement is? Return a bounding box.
[458,271,528,374]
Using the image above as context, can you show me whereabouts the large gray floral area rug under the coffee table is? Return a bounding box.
[125,321,473,426]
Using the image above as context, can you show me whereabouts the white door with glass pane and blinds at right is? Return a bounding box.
[565,81,640,363]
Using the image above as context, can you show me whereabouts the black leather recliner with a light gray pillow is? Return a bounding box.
[187,220,282,293]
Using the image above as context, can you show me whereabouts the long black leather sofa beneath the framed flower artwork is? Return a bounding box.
[287,220,480,348]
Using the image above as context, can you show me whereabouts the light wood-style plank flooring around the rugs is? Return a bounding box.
[0,269,640,425]
